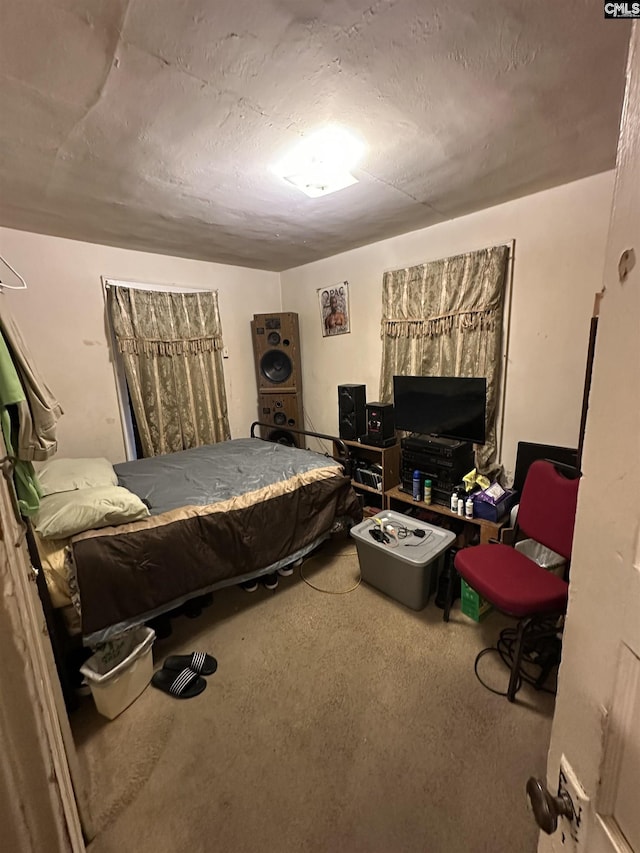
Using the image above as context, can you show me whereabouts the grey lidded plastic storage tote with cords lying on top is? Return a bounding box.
[351,510,456,610]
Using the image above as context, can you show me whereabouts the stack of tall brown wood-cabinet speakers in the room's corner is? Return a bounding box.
[251,311,304,447]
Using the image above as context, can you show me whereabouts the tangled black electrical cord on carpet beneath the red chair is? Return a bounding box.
[473,619,562,696]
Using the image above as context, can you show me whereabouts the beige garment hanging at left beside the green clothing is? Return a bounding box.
[0,302,62,462]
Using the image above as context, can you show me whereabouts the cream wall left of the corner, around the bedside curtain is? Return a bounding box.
[0,228,280,462]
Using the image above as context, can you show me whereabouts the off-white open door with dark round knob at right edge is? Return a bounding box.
[538,23,640,853]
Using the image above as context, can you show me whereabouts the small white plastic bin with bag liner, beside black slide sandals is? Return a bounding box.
[80,628,156,720]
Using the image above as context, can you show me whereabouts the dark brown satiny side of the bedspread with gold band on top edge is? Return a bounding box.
[71,467,362,642]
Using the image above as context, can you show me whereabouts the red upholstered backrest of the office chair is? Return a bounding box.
[518,459,580,560]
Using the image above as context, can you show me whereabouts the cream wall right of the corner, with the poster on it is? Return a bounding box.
[281,172,613,480]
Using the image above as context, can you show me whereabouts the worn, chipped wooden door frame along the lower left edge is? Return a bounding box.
[0,442,87,853]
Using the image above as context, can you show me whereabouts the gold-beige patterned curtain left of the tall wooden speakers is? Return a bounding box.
[107,286,229,456]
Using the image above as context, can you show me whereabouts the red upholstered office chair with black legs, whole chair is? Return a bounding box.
[444,460,580,702]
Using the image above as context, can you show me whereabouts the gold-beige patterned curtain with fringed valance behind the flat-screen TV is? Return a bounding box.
[380,246,509,471]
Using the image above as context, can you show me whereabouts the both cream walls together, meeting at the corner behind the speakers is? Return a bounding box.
[0,173,613,472]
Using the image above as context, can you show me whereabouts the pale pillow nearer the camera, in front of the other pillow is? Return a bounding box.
[33,486,149,539]
